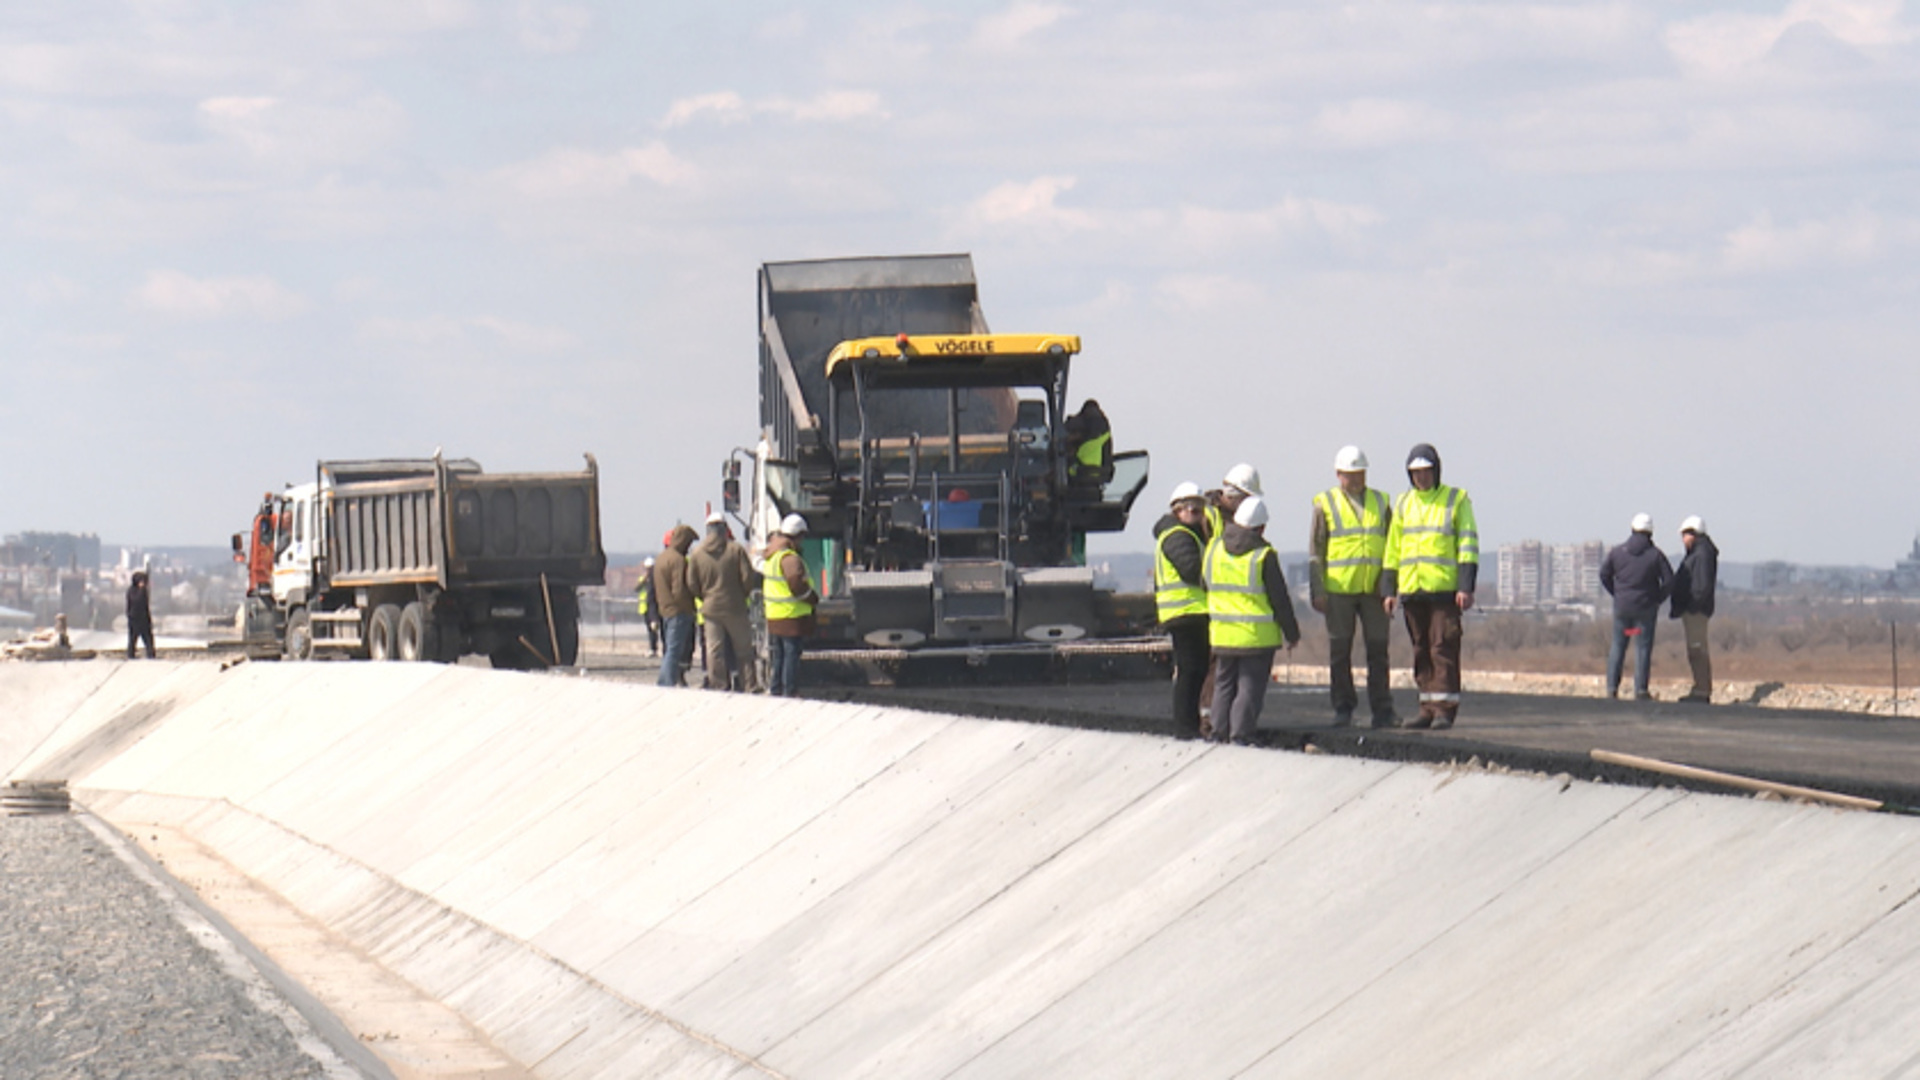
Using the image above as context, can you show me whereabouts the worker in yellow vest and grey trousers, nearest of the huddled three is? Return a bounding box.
[1206,496,1300,746]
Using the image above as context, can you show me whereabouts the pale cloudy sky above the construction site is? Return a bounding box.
[0,0,1920,565]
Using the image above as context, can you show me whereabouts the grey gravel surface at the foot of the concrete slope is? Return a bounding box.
[0,815,326,1080]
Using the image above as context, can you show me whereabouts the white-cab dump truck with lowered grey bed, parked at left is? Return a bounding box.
[232,452,607,671]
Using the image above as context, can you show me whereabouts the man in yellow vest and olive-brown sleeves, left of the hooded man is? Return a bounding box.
[1308,446,1400,728]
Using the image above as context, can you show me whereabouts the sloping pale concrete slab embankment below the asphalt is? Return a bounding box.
[0,663,1920,1080]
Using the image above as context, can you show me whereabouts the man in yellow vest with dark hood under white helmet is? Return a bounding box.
[1380,442,1480,728]
